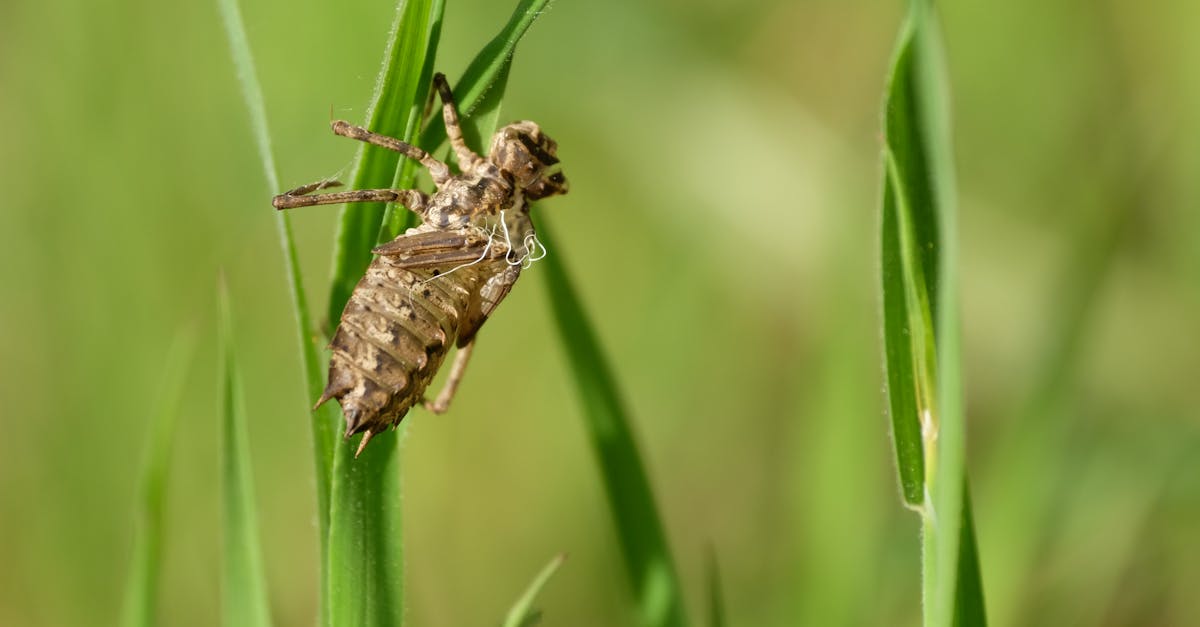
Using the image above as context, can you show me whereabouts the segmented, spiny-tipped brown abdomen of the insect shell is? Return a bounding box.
[323,257,479,435]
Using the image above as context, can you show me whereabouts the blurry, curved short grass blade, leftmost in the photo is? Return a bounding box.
[120,333,196,627]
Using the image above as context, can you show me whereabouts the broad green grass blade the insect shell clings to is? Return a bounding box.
[323,0,444,626]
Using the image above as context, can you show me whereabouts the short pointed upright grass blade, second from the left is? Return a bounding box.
[218,283,271,627]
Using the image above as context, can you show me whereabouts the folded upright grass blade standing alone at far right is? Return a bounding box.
[881,0,986,627]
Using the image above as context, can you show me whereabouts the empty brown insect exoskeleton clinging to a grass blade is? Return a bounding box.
[272,73,566,455]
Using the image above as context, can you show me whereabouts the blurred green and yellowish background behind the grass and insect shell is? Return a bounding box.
[0,0,1200,626]
